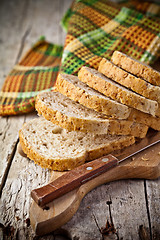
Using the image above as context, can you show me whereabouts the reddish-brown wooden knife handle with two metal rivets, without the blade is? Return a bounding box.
[31,154,118,207]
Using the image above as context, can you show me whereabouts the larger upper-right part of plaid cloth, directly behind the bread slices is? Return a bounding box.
[61,0,160,74]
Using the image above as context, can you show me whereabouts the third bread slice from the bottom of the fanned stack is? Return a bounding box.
[56,74,160,130]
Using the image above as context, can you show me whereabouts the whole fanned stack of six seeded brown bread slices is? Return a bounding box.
[19,51,160,171]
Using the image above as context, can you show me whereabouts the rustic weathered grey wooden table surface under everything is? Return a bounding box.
[0,0,160,240]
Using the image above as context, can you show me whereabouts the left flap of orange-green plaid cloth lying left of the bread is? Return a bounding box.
[0,40,63,116]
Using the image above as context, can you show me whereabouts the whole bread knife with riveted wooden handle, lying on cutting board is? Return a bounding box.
[31,129,160,207]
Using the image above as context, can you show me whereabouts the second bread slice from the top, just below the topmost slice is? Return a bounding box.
[98,58,160,103]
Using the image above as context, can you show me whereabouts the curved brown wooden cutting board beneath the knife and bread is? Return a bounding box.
[30,143,160,235]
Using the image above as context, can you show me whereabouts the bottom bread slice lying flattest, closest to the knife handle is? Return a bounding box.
[19,117,135,171]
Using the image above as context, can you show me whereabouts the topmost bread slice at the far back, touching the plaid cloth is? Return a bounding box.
[111,51,160,86]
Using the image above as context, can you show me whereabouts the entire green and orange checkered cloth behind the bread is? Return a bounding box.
[0,0,160,116]
